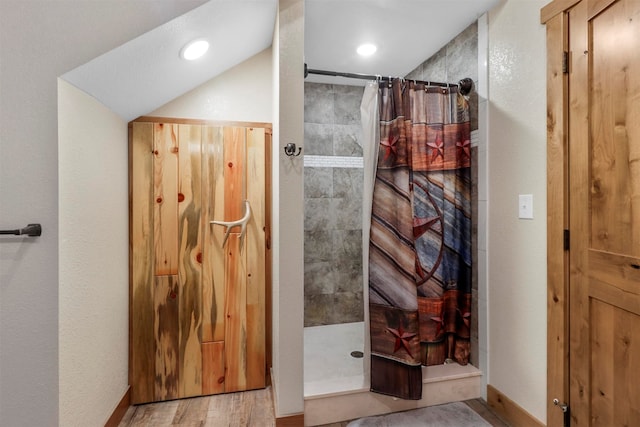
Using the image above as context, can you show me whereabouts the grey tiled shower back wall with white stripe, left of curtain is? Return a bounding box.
[304,83,364,326]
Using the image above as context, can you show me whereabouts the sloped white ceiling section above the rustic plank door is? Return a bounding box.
[62,0,276,121]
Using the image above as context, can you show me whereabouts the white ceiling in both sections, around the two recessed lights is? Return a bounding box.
[62,0,500,120]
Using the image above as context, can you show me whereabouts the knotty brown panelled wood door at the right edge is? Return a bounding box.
[568,0,640,426]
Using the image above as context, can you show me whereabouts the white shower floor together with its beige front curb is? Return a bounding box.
[304,322,482,426]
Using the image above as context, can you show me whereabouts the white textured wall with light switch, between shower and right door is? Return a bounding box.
[487,0,547,422]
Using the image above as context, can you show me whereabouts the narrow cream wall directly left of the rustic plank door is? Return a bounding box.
[58,80,129,426]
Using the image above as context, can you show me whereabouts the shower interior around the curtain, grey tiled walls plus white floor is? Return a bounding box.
[303,22,486,397]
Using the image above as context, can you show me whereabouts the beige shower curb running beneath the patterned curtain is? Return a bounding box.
[304,363,482,426]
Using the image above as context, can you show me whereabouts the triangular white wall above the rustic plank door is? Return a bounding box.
[148,48,273,123]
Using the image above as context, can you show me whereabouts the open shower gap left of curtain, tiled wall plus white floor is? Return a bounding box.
[304,82,366,396]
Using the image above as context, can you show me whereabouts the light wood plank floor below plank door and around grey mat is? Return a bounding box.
[119,387,509,427]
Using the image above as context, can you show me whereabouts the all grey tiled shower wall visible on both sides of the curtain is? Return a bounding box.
[304,23,478,354]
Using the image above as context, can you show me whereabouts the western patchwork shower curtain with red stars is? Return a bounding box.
[369,79,471,400]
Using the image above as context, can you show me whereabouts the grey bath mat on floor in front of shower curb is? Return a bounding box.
[347,402,491,427]
